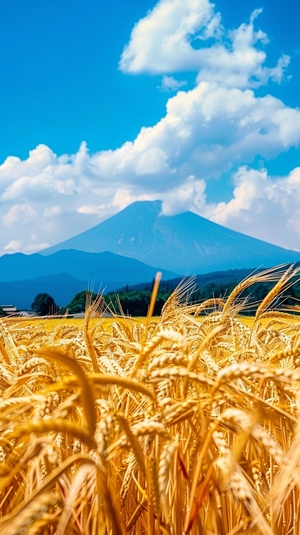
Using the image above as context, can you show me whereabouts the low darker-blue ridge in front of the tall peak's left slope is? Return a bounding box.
[0,250,177,309]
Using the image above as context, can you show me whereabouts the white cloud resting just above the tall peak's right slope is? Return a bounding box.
[203,166,300,250]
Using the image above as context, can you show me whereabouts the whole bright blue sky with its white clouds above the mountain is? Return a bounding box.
[0,0,300,254]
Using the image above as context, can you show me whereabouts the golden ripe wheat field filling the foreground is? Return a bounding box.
[0,268,300,535]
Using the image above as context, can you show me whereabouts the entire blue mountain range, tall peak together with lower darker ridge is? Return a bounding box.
[0,201,300,308]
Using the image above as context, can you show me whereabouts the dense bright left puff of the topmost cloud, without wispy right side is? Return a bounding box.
[120,0,219,74]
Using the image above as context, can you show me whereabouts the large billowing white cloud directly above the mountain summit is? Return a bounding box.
[92,82,300,188]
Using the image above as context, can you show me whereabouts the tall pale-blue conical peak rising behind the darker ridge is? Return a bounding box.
[41,201,300,275]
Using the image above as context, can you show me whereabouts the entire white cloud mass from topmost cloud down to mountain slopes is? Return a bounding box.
[0,0,300,254]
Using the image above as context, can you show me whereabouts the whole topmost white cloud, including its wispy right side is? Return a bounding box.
[120,0,289,88]
